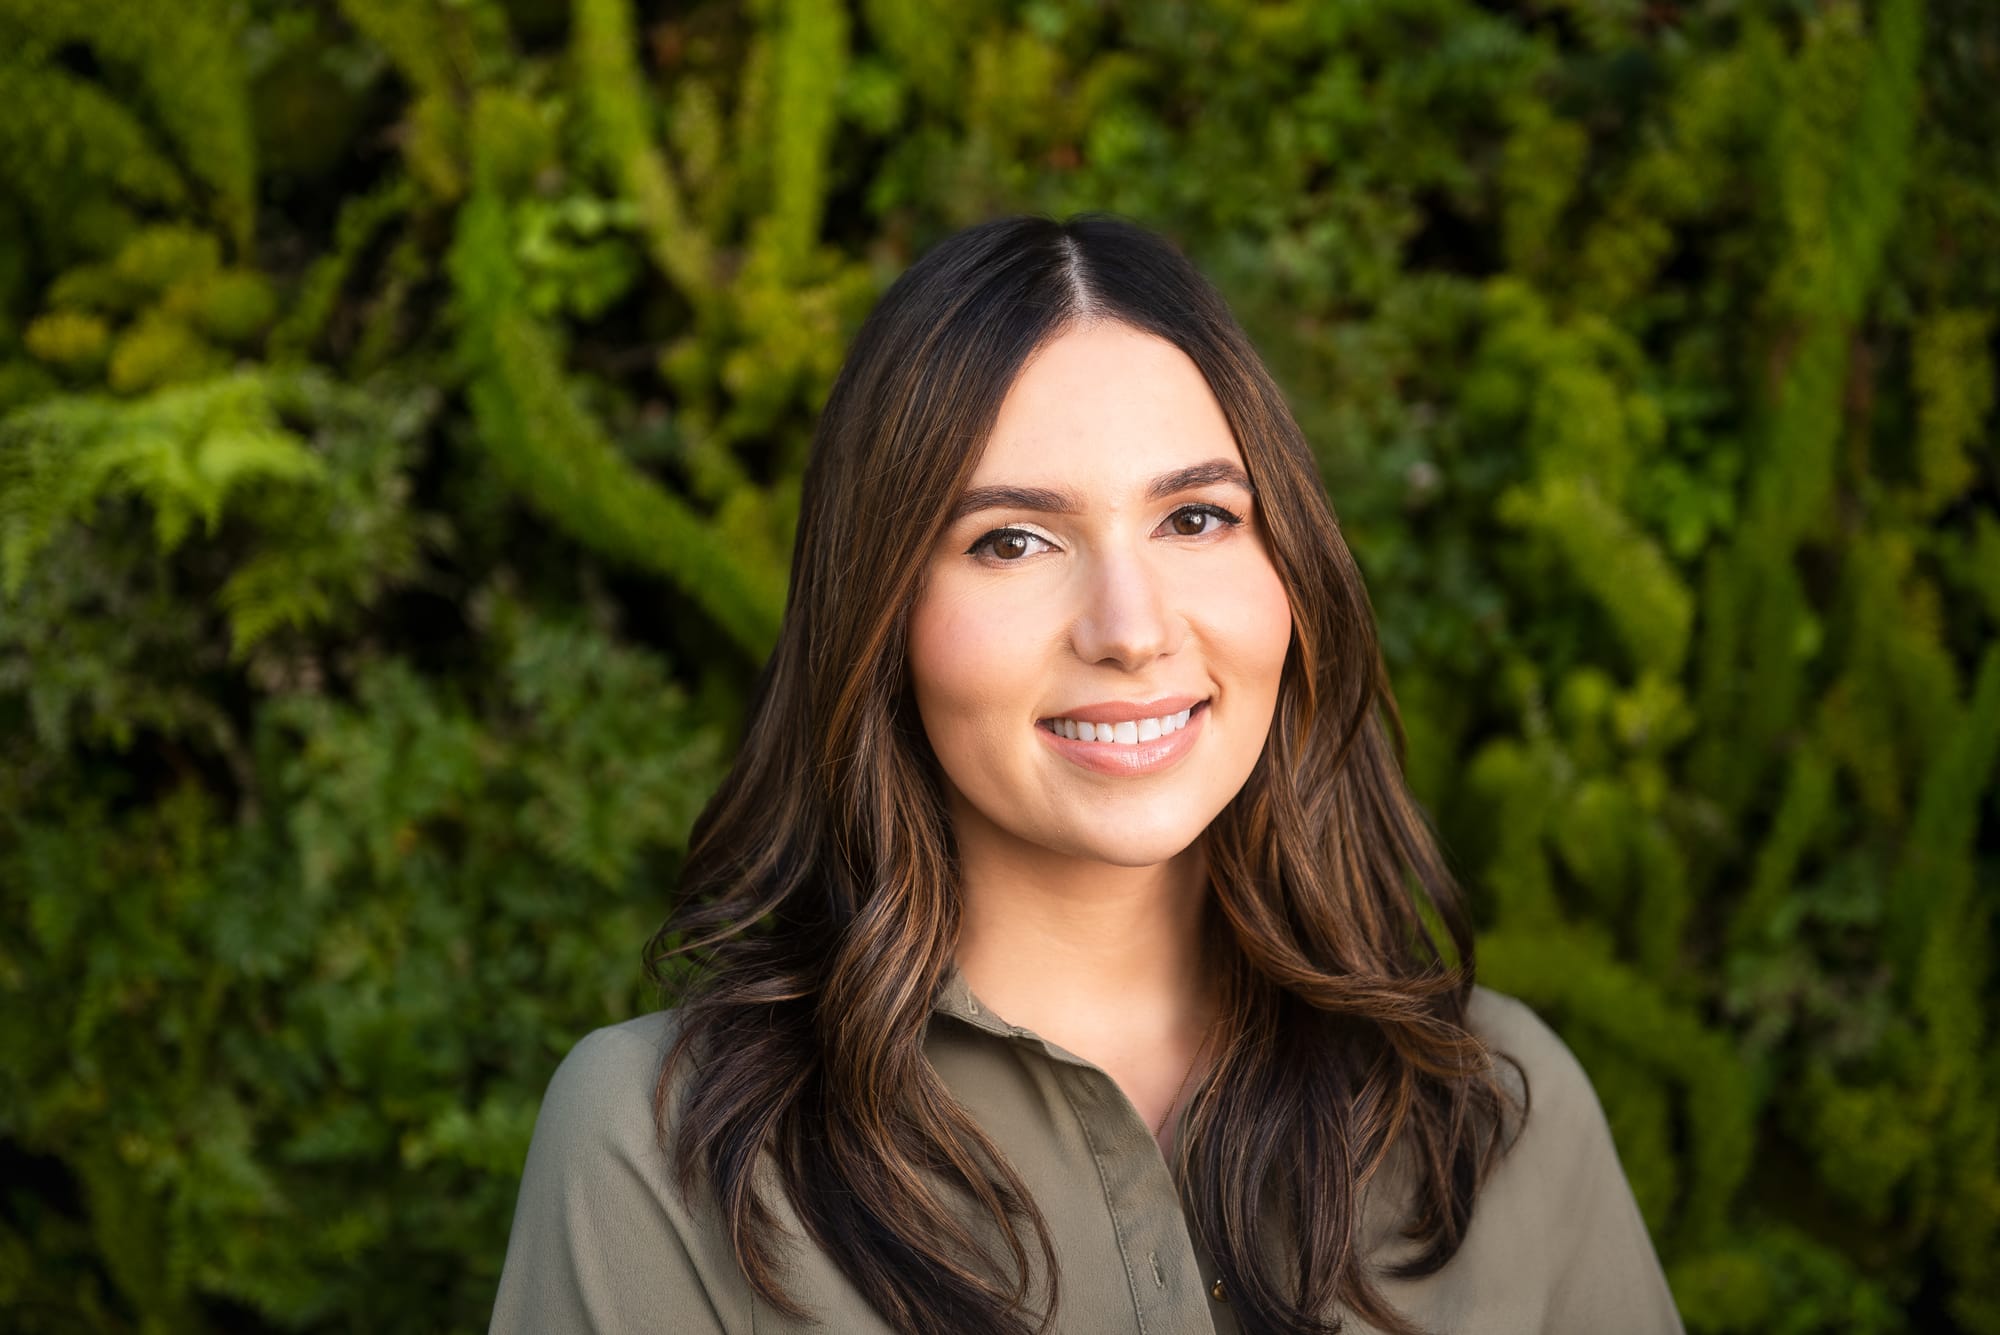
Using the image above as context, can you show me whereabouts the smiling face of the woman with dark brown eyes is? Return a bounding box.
[910,322,1292,867]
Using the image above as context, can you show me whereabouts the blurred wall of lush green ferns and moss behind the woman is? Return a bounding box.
[0,0,2000,1335]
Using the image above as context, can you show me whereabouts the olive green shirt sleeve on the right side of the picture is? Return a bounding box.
[1474,993,1682,1335]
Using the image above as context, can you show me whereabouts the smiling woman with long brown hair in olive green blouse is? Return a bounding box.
[494,216,1680,1335]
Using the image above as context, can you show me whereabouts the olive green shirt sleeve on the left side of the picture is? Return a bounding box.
[490,1025,726,1335]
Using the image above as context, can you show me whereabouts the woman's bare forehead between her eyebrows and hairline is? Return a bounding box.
[972,322,1242,490]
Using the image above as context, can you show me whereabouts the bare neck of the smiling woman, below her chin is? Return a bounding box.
[958,825,1212,1047]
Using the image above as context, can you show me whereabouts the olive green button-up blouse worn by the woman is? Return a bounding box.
[492,973,1682,1335]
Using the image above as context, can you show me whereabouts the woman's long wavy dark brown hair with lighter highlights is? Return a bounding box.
[646,216,1506,1335]
